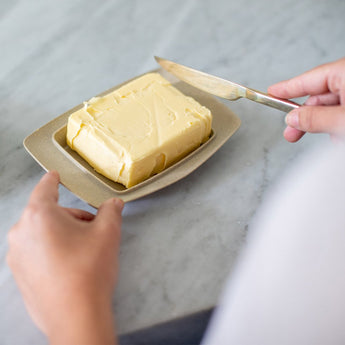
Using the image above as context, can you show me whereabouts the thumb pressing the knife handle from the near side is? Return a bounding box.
[285,106,345,135]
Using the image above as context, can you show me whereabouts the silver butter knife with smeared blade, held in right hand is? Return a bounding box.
[155,56,301,113]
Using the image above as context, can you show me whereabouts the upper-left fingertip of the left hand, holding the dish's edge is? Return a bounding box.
[29,171,60,204]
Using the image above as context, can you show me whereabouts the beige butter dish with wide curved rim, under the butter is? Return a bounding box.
[23,69,240,208]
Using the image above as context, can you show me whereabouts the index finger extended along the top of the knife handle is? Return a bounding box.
[268,59,345,98]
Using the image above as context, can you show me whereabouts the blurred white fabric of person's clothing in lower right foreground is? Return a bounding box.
[203,147,345,345]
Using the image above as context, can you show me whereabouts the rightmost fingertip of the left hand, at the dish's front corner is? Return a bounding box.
[95,198,124,228]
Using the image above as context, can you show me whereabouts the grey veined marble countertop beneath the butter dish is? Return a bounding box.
[0,0,345,345]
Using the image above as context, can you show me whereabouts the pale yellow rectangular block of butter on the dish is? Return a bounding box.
[67,73,212,188]
